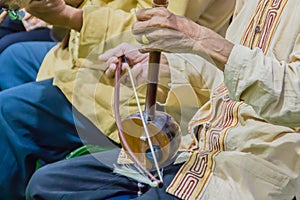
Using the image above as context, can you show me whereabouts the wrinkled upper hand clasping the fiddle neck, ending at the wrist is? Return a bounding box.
[132,8,201,53]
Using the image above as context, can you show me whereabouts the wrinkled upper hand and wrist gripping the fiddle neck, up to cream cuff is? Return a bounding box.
[132,7,233,65]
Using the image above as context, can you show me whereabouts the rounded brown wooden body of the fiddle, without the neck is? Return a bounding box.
[121,111,181,170]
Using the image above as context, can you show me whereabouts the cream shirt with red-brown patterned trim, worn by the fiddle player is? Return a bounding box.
[167,0,300,200]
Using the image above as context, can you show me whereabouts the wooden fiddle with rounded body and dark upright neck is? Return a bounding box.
[115,0,181,187]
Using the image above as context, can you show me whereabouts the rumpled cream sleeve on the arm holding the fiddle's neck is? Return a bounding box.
[224,35,300,127]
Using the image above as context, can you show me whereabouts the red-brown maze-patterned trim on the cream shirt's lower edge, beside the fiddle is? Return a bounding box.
[167,84,242,199]
